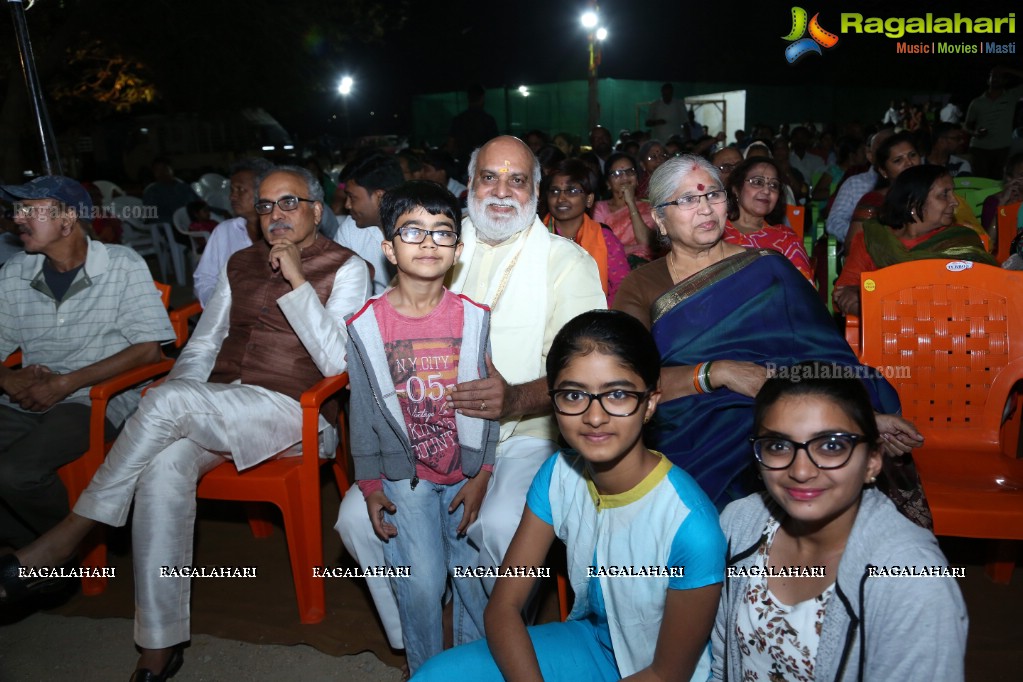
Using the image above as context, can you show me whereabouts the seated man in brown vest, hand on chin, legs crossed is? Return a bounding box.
[0,167,372,680]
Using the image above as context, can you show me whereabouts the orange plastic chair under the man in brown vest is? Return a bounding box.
[196,374,350,625]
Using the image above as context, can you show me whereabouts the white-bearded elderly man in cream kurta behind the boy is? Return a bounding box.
[337,136,607,648]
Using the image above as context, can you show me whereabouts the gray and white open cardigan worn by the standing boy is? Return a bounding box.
[347,294,499,488]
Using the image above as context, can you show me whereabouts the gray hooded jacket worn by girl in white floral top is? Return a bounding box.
[712,489,968,682]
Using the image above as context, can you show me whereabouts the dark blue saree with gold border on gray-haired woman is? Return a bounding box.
[647,249,899,509]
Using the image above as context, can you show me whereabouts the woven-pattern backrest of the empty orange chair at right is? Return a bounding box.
[860,260,1023,451]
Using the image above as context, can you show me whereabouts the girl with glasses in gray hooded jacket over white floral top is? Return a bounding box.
[712,362,968,682]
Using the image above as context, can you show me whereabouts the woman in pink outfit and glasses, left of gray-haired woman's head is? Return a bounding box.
[593,152,654,268]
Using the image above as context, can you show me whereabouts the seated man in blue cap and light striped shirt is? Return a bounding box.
[0,176,174,548]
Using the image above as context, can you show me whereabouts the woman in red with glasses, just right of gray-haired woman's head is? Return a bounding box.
[724,156,813,281]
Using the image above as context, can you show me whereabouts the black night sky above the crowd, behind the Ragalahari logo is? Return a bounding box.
[325,0,1023,139]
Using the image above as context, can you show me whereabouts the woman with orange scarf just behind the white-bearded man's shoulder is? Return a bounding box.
[540,158,629,306]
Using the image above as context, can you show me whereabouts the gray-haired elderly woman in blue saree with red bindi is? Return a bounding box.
[614,155,930,527]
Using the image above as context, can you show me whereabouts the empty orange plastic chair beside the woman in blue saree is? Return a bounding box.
[860,260,1023,583]
